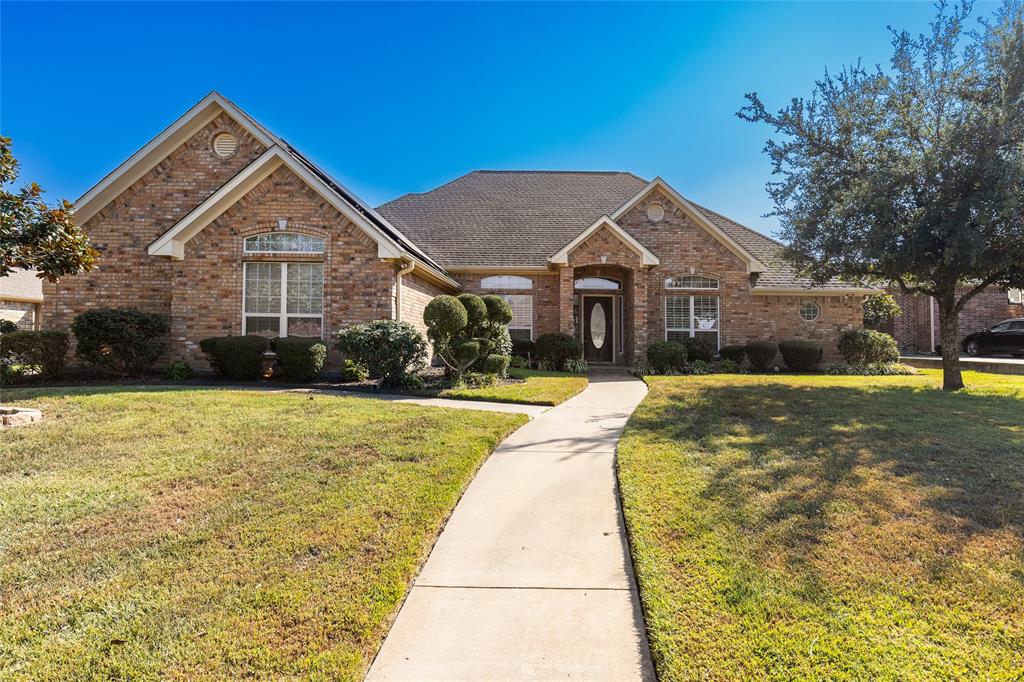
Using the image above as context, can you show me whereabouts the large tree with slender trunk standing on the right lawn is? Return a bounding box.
[737,0,1024,389]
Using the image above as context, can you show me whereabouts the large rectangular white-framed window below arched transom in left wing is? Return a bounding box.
[242,263,324,338]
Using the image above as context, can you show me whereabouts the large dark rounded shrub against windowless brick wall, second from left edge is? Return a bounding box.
[72,308,170,377]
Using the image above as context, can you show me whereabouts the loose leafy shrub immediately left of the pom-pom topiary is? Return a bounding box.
[335,319,425,388]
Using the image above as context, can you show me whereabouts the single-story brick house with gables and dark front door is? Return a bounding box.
[44,92,870,364]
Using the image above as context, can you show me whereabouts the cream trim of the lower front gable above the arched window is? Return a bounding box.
[148,145,409,260]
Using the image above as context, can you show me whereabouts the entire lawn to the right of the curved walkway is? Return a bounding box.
[618,372,1024,682]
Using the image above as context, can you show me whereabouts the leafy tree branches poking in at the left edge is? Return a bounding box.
[0,137,99,282]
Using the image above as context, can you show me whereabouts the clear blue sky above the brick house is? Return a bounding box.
[0,1,994,237]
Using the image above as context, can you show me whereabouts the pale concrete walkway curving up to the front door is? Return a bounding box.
[367,371,654,682]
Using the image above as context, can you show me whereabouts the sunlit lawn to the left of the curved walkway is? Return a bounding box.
[0,388,525,680]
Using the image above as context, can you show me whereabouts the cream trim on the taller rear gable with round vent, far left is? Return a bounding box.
[75,92,280,224]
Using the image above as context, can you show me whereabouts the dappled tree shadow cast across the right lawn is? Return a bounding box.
[631,383,1024,590]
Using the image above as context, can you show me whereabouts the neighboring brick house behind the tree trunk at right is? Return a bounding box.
[882,287,1024,353]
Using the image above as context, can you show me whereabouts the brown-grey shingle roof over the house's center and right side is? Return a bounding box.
[377,171,864,288]
